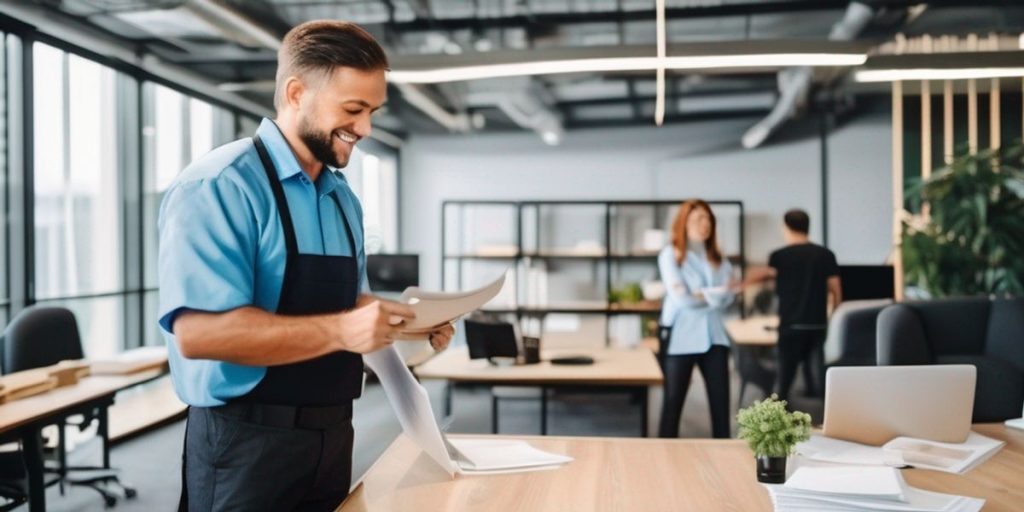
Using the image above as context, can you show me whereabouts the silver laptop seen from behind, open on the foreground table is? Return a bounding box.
[823,365,977,445]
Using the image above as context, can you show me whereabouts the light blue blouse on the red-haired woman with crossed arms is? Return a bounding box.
[657,245,735,355]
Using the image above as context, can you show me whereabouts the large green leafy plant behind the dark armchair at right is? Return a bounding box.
[902,141,1024,297]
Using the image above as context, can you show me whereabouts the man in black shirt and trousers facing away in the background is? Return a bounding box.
[748,210,843,399]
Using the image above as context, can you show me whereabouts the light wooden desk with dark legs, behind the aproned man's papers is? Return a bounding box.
[414,347,663,435]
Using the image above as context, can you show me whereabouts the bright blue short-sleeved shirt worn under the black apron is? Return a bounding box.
[159,119,367,407]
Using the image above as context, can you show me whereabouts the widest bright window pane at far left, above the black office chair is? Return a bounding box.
[33,44,124,356]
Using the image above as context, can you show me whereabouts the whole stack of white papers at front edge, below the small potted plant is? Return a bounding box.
[765,467,985,512]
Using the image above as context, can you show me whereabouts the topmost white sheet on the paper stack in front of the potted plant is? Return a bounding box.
[785,466,904,501]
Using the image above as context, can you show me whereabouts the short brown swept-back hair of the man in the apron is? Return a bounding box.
[273,19,388,109]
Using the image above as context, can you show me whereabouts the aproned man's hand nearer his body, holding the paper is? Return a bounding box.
[337,295,416,353]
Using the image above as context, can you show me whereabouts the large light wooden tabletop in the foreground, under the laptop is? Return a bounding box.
[339,425,1024,512]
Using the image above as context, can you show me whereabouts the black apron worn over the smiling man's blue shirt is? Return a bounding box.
[179,135,362,510]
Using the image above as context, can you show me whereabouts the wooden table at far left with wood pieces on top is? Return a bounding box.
[0,369,167,511]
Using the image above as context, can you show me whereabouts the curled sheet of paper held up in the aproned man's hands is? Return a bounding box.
[393,271,508,334]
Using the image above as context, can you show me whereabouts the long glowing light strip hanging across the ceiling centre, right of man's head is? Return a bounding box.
[388,53,867,84]
